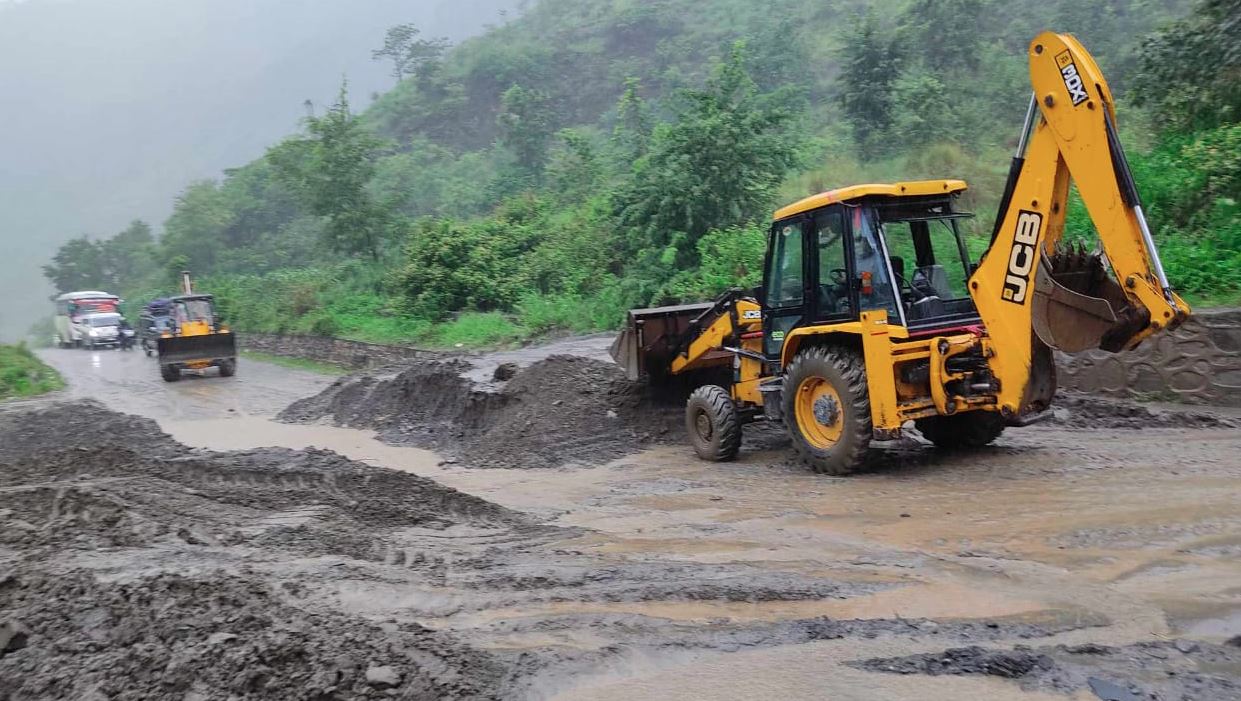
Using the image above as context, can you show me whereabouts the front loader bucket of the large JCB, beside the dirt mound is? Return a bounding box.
[612,301,715,383]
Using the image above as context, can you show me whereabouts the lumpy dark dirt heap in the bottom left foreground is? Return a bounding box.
[0,572,503,701]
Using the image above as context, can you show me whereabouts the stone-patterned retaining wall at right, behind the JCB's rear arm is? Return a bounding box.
[1057,309,1241,407]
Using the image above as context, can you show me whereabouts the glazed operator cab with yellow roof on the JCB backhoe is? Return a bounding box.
[763,180,980,359]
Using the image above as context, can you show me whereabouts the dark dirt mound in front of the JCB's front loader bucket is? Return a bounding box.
[279,355,684,468]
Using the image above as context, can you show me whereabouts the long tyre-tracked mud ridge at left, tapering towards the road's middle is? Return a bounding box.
[0,439,527,560]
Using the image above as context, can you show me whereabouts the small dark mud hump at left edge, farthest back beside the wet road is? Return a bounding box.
[0,400,185,462]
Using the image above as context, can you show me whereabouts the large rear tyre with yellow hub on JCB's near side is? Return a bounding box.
[784,346,874,475]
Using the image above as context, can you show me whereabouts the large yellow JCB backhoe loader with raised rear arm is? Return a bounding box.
[612,32,1190,474]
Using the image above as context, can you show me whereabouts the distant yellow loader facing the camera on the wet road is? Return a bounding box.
[155,273,237,382]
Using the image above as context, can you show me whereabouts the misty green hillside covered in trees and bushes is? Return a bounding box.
[47,0,1241,345]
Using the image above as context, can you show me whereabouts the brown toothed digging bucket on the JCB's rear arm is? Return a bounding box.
[1031,248,1134,352]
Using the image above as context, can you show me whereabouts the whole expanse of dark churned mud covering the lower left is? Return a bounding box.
[0,402,531,701]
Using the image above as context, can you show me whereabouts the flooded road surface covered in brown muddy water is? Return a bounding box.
[26,340,1241,700]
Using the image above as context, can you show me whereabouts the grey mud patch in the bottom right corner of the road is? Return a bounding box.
[853,640,1241,701]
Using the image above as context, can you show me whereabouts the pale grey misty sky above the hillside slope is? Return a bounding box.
[0,0,516,339]
